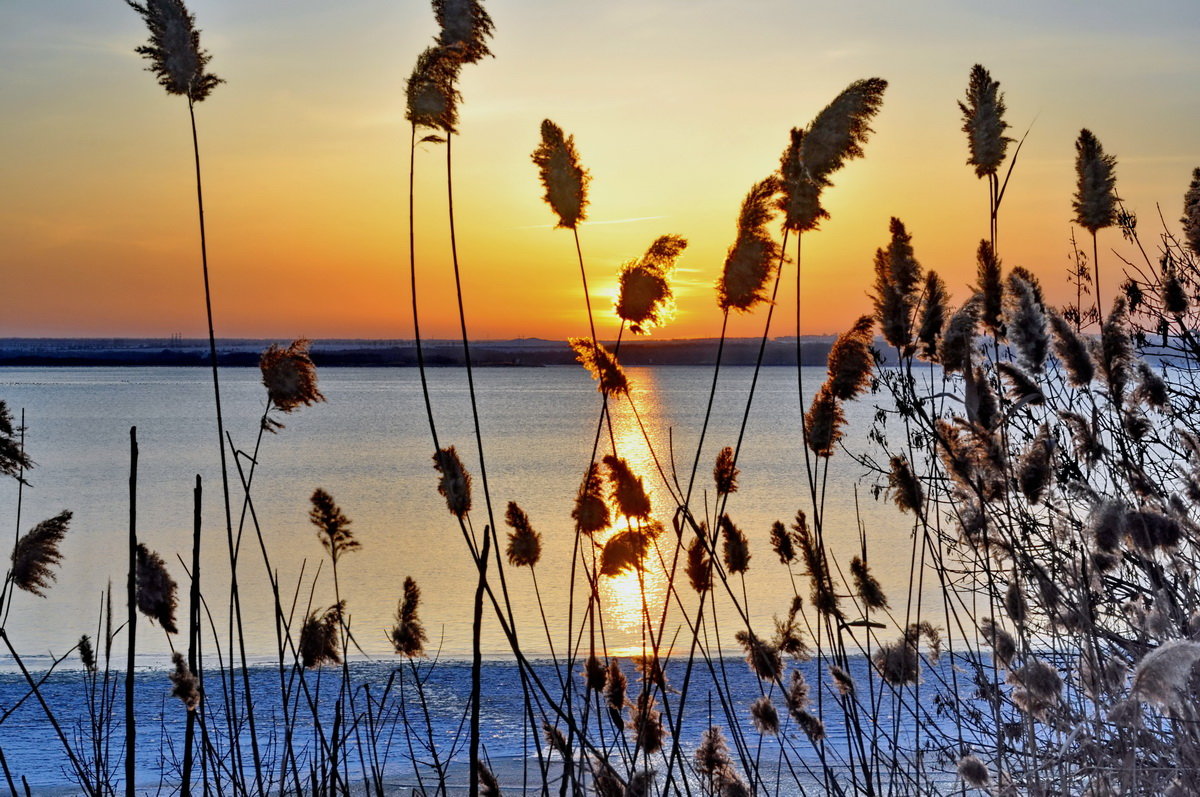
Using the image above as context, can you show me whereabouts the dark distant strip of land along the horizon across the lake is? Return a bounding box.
[0,336,902,367]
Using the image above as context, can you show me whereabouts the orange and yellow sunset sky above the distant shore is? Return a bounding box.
[0,0,1200,340]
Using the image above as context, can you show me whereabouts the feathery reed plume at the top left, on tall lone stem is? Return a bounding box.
[126,0,222,102]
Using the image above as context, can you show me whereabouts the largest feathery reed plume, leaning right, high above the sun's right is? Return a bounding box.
[779,78,888,232]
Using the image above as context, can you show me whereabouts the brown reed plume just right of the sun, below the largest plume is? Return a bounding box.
[716,178,781,312]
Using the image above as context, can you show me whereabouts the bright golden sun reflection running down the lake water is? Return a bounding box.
[595,372,676,657]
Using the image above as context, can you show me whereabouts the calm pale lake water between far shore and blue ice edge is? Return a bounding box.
[0,367,911,666]
